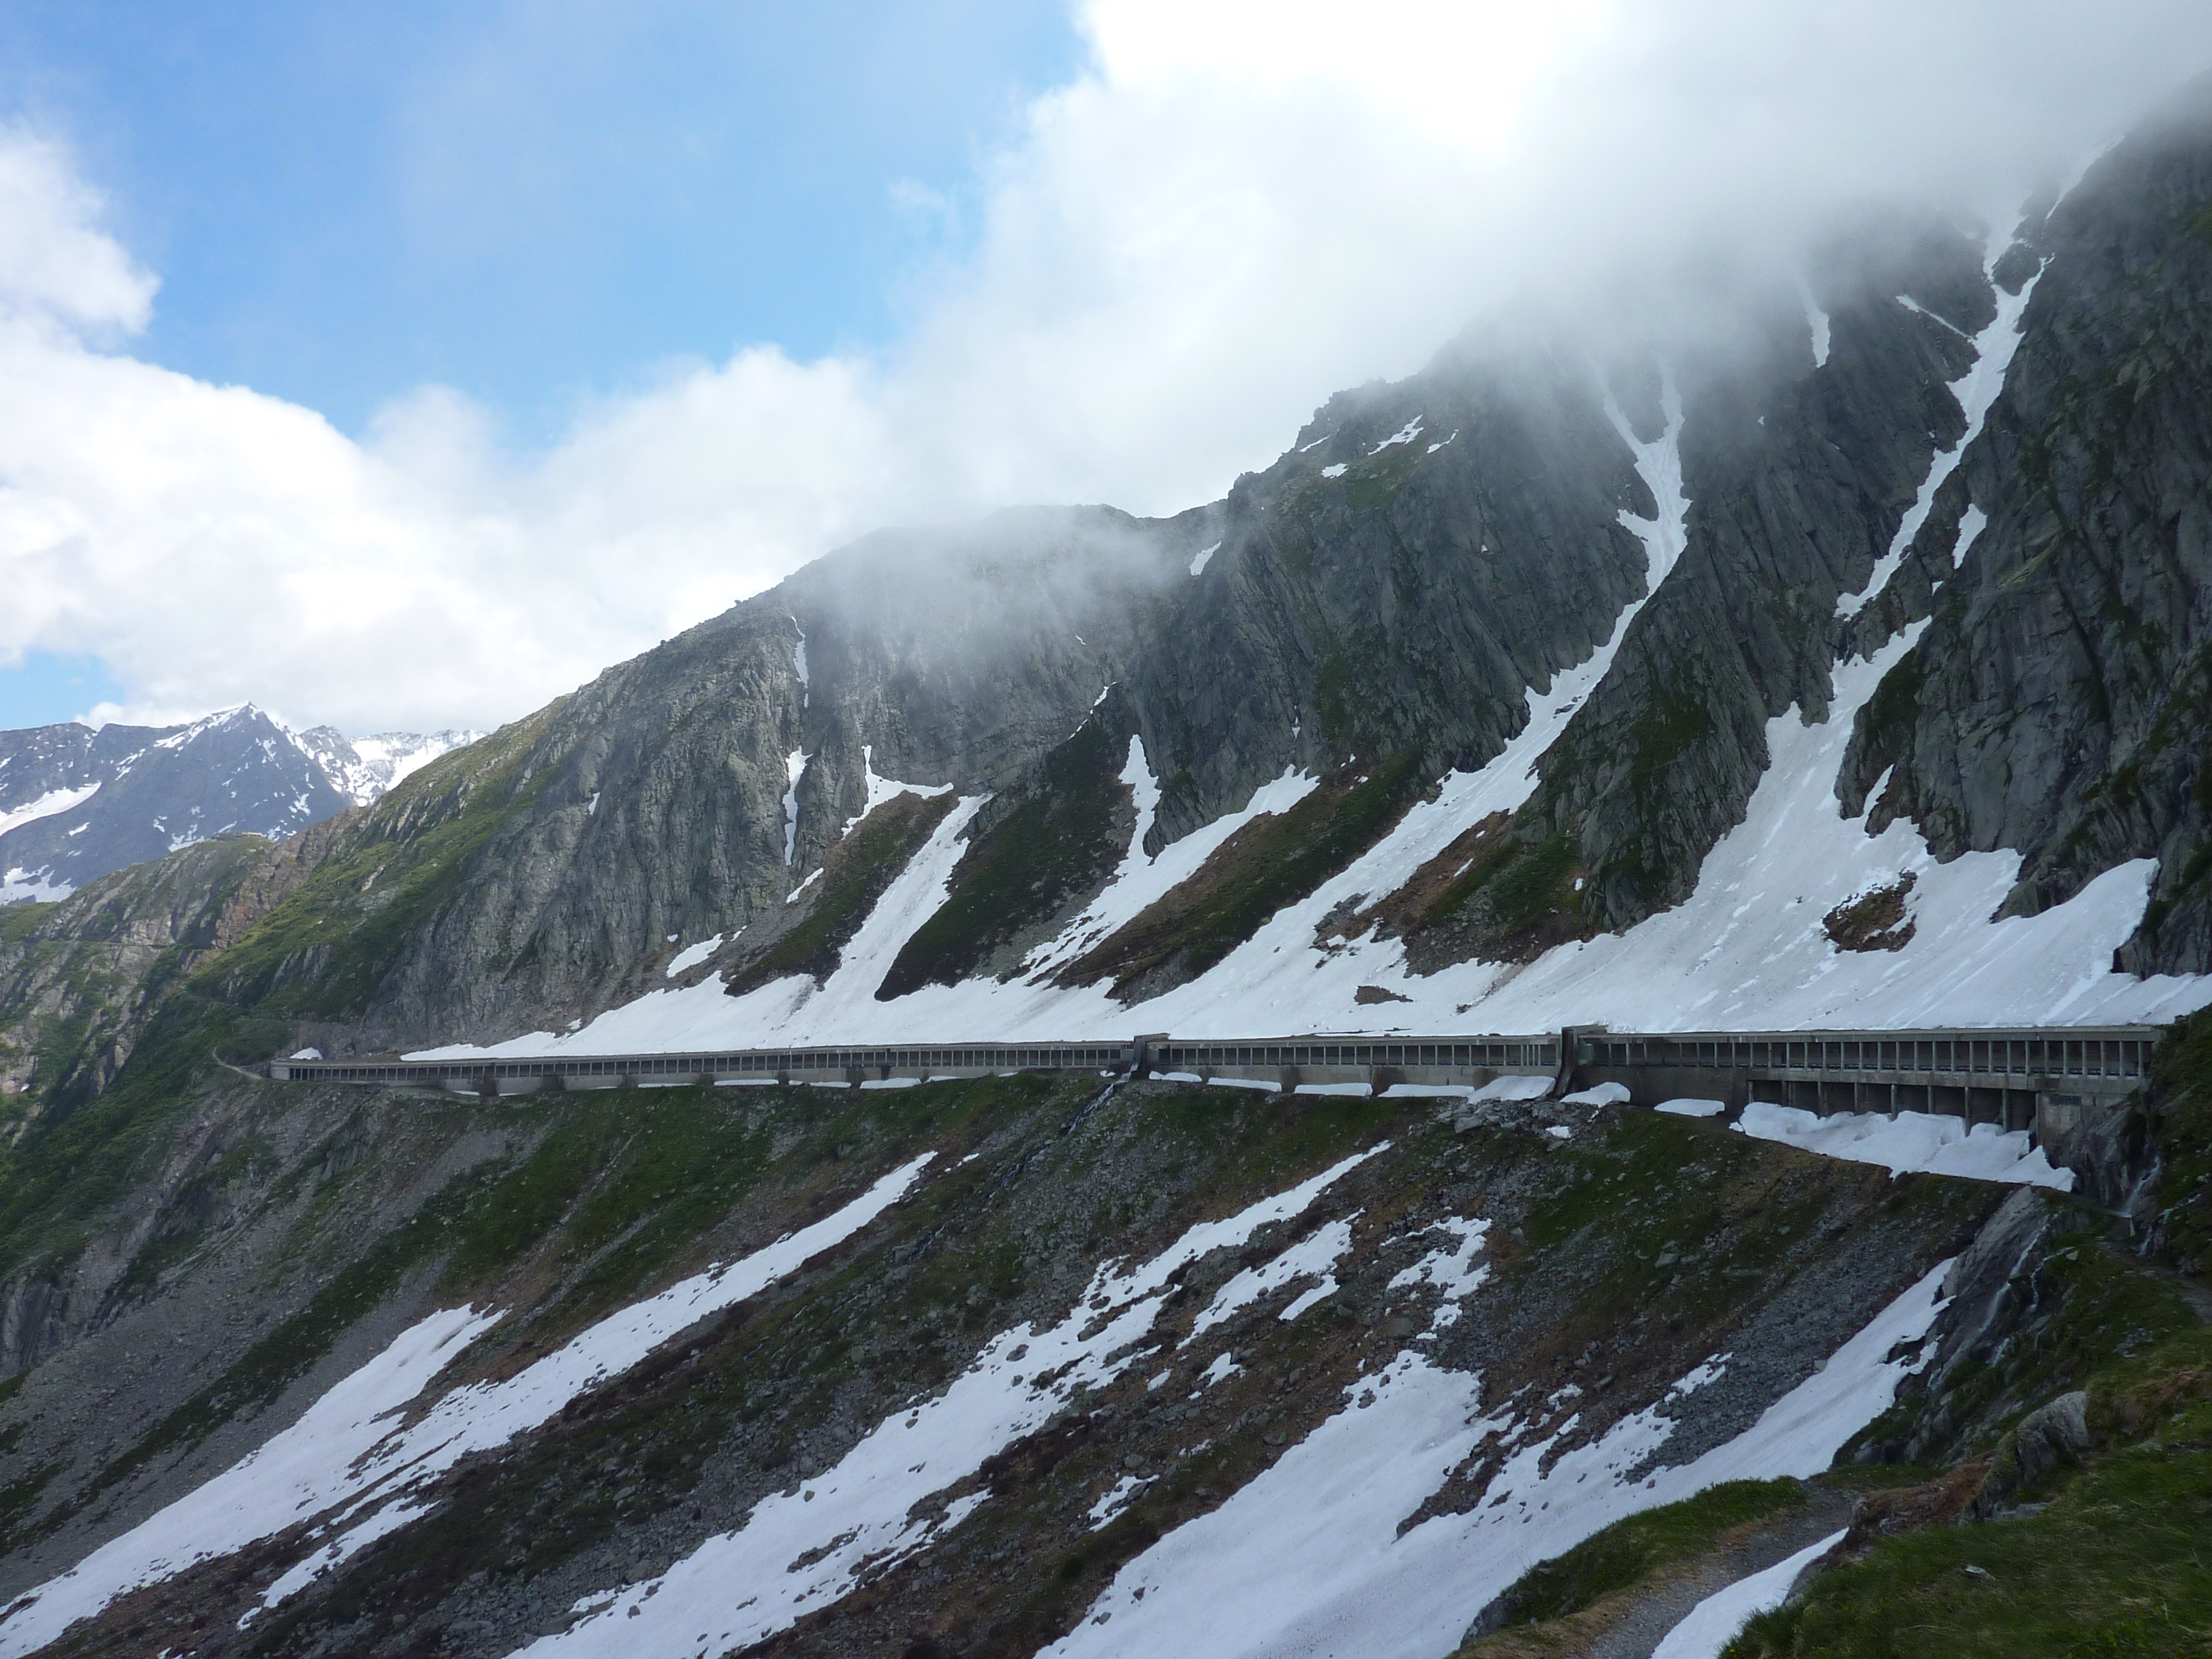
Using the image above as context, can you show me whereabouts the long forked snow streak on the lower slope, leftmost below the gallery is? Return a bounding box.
[0,1155,933,1657]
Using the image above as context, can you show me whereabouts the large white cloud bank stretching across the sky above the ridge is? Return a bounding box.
[0,0,2212,730]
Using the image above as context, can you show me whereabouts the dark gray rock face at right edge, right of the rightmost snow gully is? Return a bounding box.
[1843,86,2212,973]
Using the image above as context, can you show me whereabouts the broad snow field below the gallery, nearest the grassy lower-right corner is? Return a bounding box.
[1047,1263,1949,1659]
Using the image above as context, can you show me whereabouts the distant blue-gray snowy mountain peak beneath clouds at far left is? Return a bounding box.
[0,703,478,902]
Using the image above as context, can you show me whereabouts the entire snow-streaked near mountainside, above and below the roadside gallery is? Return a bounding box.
[0,68,2212,1659]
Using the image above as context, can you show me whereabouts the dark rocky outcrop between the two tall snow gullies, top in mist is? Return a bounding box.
[1431,219,1995,960]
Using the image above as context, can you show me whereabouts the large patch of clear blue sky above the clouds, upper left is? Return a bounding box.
[0,0,1079,442]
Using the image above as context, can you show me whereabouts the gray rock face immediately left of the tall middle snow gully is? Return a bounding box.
[1130,330,1652,845]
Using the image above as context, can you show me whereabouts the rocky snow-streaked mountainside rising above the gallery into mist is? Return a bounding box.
[112,84,2212,1053]
